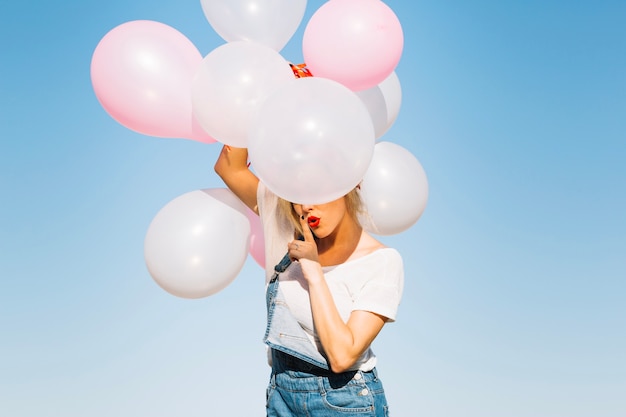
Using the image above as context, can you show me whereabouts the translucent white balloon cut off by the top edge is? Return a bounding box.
[201,0,307,51]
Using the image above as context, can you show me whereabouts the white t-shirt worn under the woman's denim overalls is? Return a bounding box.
[257,183,404,371]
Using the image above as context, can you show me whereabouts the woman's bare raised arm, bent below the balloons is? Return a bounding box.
[214,145,259,214]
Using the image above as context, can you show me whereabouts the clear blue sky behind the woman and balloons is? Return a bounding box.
[0,0,626,417]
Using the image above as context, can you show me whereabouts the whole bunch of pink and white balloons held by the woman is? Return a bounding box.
[91,0,427,298]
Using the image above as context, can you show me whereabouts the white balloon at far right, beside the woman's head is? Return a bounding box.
[361,142,428,235]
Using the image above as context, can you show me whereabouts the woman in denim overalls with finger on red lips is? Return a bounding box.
[215,146,404,417]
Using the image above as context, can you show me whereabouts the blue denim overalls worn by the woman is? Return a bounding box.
[263,250,388,417]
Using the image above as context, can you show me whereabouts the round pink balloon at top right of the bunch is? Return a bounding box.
[303,0,404,91]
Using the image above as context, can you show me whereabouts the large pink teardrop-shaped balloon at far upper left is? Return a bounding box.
[91,20,215,143]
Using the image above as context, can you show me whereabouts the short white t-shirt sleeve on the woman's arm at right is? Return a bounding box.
[352,248,404,322]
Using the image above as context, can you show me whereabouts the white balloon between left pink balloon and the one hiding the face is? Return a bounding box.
[191,41,294,148]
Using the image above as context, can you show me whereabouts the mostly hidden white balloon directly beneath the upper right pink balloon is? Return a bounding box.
[356,71,402,139]
